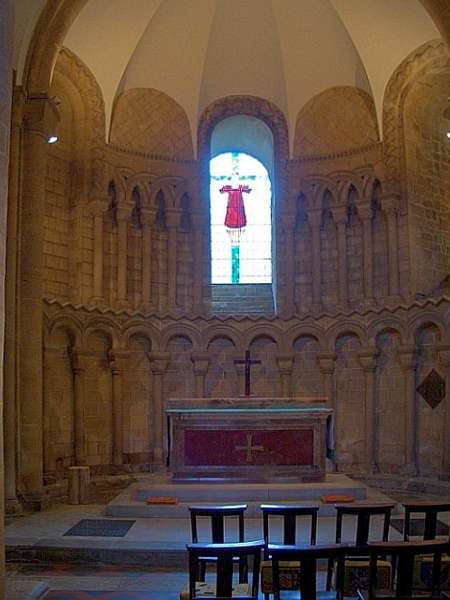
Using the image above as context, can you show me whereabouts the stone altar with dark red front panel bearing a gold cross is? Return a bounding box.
[166,398,333,482]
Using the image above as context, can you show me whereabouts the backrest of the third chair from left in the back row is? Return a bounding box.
[334,502,395,546]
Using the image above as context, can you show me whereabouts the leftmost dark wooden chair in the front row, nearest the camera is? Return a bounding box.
[180,540,264,600]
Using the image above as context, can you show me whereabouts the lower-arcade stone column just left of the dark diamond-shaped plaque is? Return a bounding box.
[398,346,417,475]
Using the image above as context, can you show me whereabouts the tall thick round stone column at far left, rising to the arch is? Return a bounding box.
[18,97,58,495]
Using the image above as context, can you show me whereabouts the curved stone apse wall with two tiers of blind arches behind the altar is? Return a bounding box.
[6,38,450,496]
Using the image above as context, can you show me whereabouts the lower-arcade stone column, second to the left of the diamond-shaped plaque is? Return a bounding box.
[358,349,379,473]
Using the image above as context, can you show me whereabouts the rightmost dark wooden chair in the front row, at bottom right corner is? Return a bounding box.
[358,540,450,600]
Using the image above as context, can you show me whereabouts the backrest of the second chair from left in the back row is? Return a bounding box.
[260,504,319,545]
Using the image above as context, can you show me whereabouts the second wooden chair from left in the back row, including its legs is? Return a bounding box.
[260,504,319,598]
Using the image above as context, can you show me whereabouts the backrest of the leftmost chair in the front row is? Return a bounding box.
[186,540,264,600]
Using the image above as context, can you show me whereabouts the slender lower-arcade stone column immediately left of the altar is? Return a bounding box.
[150,352,170,470]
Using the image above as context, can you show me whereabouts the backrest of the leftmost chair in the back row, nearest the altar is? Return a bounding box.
[189,504,247,544]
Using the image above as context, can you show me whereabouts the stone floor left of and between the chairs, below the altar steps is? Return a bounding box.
[5,486,450,600]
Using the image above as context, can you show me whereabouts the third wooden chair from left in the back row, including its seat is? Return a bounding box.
[327,502,395,595]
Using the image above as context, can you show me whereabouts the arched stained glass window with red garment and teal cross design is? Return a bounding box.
[210,152,272,283]
